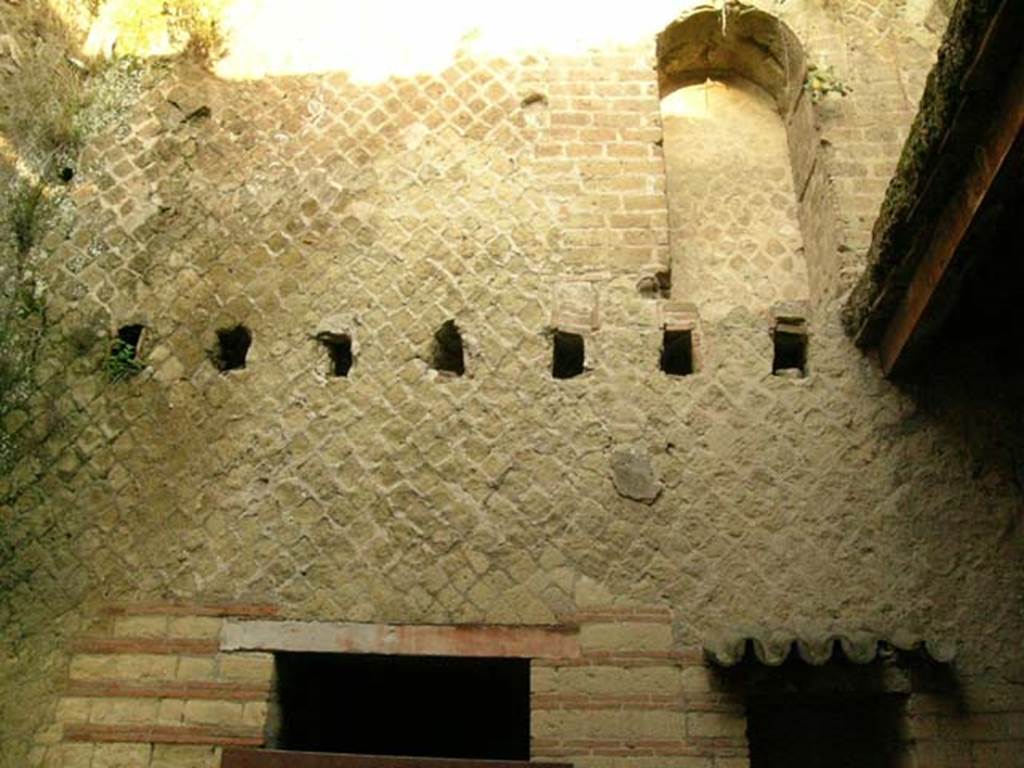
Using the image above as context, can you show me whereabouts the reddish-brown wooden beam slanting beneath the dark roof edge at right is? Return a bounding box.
[879,3,1024,376]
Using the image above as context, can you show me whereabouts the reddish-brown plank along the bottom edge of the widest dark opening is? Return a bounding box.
[220,749,572,768]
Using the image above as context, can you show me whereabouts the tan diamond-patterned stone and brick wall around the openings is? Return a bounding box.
[0,0,1024,768]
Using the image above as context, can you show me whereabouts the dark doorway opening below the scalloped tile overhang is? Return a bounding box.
[746,693,906,768]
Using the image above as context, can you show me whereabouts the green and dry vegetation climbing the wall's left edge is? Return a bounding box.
[0,0,148,499]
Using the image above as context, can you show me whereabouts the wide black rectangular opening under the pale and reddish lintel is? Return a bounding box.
[275,653,529,760]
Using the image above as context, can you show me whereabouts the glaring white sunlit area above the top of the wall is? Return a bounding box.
[72,0,716,84]
